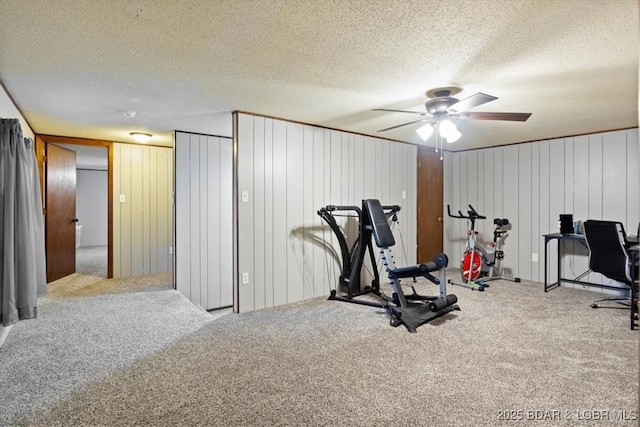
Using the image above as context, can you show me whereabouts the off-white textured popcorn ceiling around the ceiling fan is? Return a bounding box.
[0,0,639,150]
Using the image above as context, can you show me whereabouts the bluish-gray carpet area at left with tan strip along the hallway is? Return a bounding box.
[0,274,202,426]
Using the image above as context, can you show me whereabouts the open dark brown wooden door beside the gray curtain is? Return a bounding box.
[45,144,77,282]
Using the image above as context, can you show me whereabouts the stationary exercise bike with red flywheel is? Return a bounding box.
[447,205,520,291]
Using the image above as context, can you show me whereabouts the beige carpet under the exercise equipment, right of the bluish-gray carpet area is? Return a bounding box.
[18,281,638,426]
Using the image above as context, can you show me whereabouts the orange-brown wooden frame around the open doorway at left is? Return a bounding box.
[36,135,113,279]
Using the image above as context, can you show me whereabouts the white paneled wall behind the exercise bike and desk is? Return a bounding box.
[444,128,640,292]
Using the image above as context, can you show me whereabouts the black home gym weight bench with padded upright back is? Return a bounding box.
[318,199,460,332]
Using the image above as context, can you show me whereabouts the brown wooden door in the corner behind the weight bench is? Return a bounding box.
[417,146,443,262]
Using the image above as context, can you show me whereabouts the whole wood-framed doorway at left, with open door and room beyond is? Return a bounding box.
[36,135,113,282]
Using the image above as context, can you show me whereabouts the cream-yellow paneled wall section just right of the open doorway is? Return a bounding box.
[113,143,173,277]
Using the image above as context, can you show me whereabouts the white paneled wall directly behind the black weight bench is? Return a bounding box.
[234,113,417,312]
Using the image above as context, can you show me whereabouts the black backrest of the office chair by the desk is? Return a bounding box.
[583,219,633,286]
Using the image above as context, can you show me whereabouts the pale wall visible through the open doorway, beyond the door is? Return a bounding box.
[76,169,108,246]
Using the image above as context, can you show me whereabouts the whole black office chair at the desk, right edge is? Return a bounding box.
[583,219,638,329]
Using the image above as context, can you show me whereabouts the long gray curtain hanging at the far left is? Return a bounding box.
[0,119,47,326]
